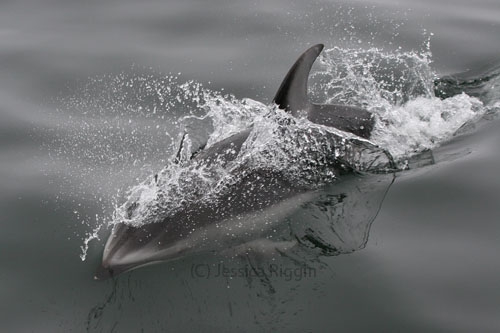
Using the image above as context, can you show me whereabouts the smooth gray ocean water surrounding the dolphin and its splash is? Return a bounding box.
[0,0,500,332]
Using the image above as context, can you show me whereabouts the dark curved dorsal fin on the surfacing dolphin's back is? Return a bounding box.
[273,44,324,115]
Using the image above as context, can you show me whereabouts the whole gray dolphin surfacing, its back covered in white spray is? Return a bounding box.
[95,44,395,279]
